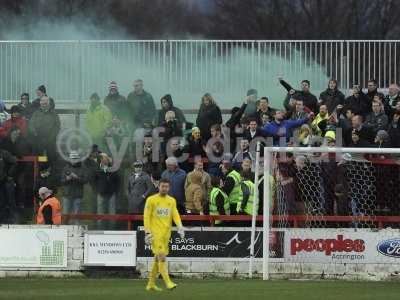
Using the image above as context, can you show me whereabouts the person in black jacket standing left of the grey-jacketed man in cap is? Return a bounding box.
[94,153,121,229]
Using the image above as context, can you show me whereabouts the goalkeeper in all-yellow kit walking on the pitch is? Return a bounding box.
[143,179,185,291]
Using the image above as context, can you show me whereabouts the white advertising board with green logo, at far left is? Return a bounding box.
[0,227,68,268]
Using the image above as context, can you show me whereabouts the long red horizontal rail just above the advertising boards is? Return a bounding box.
[63,214,400,230]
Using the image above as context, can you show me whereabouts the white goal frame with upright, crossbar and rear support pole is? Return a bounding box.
[249,144,400,280]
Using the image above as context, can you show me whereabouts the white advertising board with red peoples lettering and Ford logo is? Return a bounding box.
[284,228,400,263]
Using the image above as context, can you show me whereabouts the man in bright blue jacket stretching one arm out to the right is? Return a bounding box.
[263,110,310,146]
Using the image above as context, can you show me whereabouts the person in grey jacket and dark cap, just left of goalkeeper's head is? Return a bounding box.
[127,161,154,215]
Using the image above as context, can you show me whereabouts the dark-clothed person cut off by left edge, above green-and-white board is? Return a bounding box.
[0,149,17,224]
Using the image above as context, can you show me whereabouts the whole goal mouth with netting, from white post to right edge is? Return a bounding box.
[263,147,400,279]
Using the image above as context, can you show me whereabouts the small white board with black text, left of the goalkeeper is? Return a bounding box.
[84,231,136,266]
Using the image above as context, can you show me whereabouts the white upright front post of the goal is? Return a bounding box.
[263,147,272,280]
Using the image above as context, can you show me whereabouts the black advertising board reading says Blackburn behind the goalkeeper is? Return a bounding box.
[137,228,284,261]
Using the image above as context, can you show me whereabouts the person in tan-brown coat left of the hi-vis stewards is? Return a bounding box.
[185,171,206,215]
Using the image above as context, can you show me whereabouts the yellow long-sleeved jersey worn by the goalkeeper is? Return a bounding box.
[143,194,182,239]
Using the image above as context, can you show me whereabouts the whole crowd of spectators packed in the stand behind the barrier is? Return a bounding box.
[0,78,400,227]
